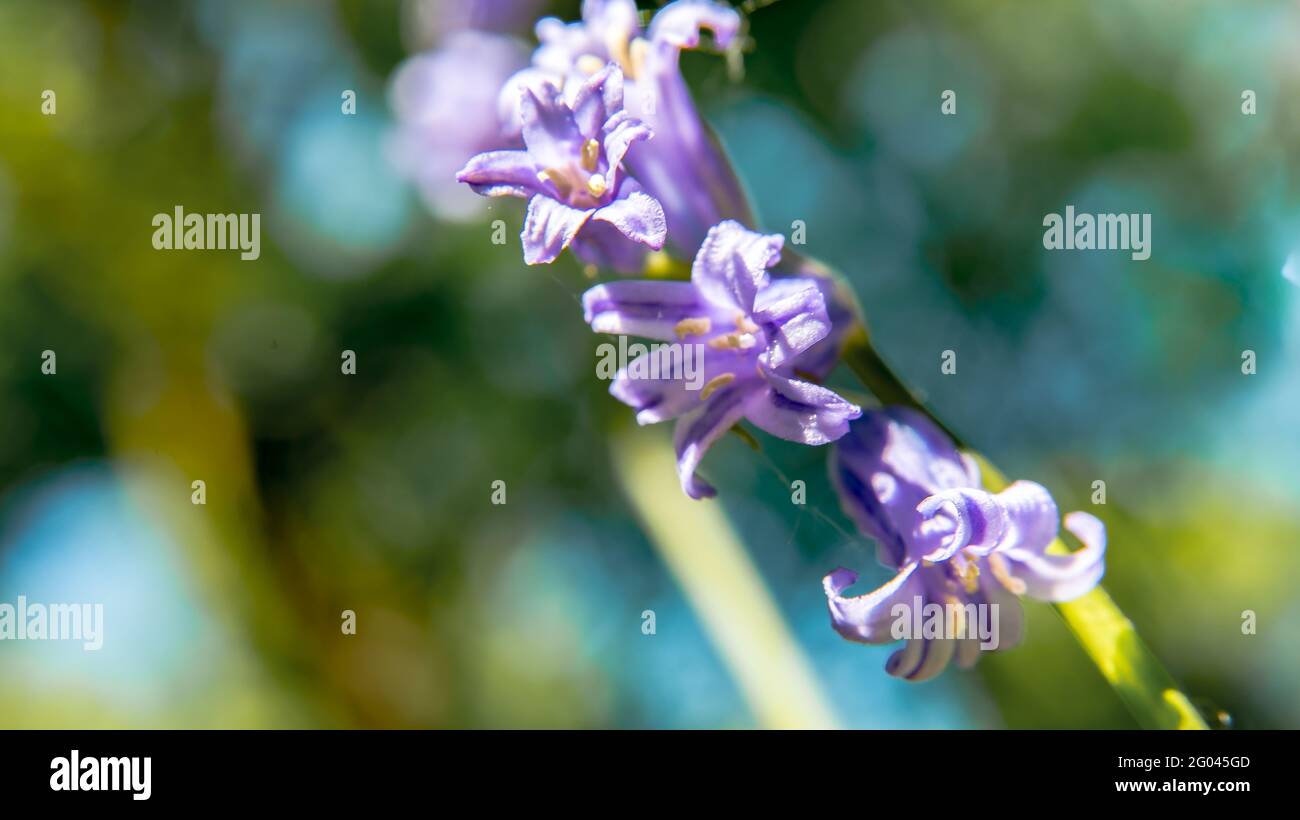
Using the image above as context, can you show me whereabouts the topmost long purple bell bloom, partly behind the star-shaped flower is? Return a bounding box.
[502,0,753,255]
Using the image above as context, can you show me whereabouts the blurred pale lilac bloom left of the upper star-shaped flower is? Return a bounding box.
[389,31,528,220]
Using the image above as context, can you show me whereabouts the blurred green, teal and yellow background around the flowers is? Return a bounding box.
[0,0,1300,728]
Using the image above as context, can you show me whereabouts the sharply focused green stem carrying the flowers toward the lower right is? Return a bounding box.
[842,324,1209,729]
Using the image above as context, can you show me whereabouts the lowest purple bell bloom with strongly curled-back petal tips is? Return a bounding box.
[824,407,1106,681]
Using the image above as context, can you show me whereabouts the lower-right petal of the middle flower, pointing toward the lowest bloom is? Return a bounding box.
[745,372,862,444]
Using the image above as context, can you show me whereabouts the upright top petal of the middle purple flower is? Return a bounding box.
[690,220,785,316]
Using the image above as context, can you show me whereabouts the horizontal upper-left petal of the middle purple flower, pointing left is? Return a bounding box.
[582,279,710,342]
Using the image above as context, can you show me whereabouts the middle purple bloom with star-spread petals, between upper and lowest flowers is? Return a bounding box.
[582,222,862,498]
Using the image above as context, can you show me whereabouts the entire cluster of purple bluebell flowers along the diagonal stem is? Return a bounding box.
[394,0,1105,680]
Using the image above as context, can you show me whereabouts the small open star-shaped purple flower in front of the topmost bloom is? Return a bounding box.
[456,66,666,270]
